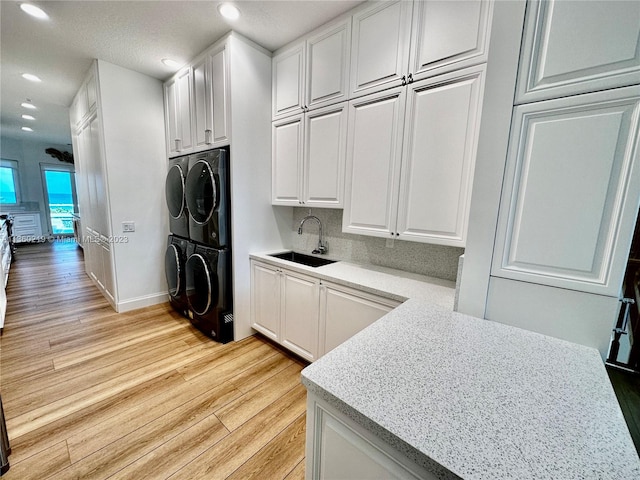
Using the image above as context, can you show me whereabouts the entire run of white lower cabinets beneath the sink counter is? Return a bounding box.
[251,260,400,362]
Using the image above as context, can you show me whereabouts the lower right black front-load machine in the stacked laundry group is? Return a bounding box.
[185,244,233,343]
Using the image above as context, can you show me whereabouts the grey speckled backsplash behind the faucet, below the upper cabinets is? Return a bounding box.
[288,207,464,281]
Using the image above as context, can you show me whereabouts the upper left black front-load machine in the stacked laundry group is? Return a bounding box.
[164,156,189,238]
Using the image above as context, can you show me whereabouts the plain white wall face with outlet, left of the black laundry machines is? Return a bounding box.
[98,60,169,311]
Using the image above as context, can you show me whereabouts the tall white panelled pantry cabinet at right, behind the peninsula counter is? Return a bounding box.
[459,1,640,357]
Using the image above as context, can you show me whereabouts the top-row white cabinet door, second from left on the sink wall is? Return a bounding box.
[304,19,351,110]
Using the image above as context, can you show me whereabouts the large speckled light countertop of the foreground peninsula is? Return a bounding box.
[302,299,640,480]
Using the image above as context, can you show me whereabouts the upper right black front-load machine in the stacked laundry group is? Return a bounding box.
[185,149,231,249]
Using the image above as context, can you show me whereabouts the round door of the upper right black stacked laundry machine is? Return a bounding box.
[186,160,220,225]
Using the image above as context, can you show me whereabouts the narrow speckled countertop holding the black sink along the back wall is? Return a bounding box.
[250,250,456,310]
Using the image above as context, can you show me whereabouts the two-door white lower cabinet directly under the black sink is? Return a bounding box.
[251,261,320,362]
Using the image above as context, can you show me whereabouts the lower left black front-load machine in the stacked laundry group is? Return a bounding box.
[164,235,195,317]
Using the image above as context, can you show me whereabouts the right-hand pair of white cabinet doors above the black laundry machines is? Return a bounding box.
[192,44,229,150]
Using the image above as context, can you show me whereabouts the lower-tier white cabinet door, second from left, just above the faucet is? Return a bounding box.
[302,102,348,208]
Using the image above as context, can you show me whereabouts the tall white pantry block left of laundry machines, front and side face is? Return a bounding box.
[70,60,167,312]
